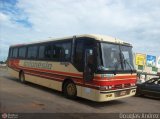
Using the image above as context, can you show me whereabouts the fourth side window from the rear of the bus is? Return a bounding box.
[27,46,37,59]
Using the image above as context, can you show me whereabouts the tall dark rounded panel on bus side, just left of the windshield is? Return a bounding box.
[83,49,94,81]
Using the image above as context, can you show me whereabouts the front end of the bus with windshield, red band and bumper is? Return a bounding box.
[94,42,136,101]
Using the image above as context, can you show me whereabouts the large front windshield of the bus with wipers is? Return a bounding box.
[101,42,134,71]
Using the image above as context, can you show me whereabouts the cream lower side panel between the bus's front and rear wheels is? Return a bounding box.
[25,74,62,91]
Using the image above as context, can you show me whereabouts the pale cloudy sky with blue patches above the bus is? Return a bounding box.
[0,0,160,60]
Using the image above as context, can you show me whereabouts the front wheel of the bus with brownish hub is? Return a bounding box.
[64,81,77,99]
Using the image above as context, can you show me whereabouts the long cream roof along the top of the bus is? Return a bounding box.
[11,34,131,47]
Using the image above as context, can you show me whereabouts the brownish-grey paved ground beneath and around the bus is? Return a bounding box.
[0,69,160,113]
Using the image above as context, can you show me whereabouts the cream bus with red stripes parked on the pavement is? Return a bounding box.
[8,34,137,102]
